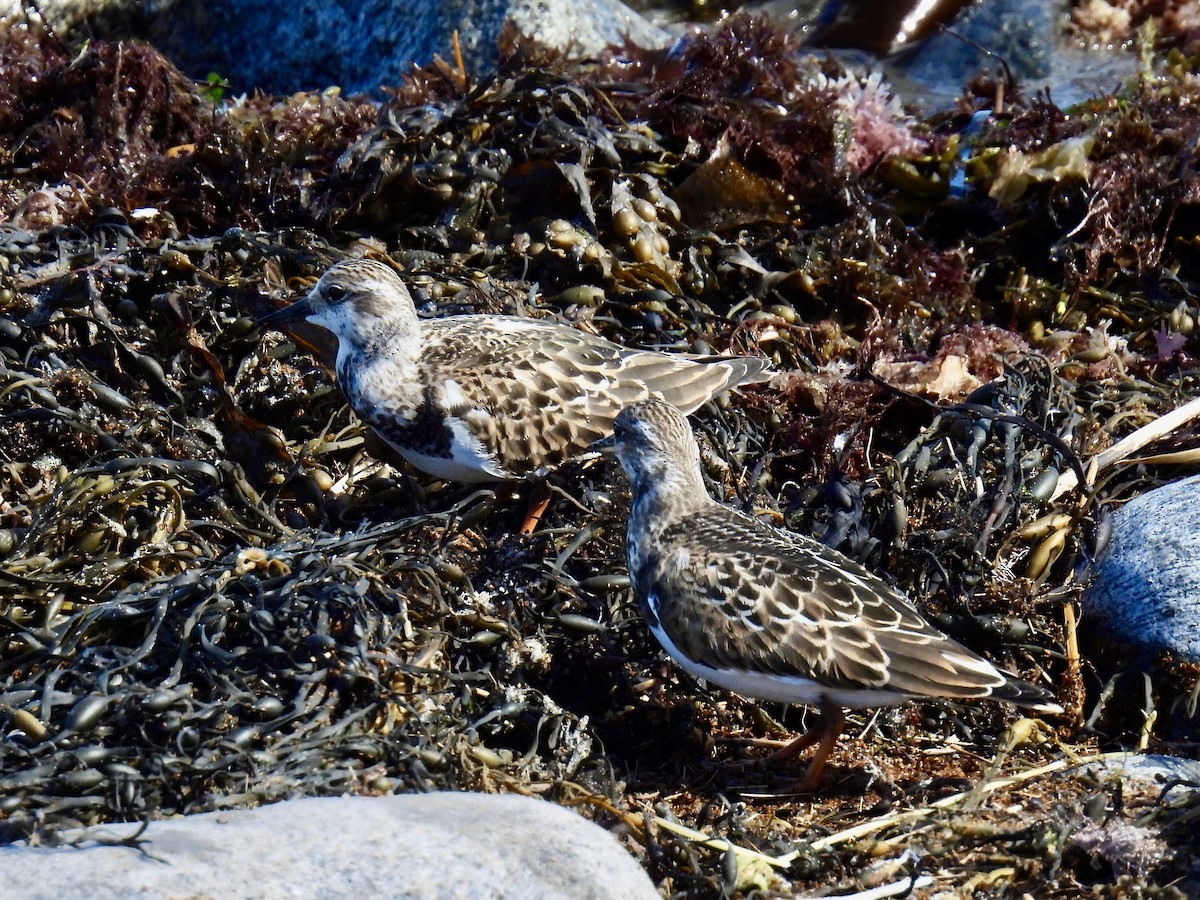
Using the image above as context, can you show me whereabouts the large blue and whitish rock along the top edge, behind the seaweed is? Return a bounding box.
[0,0,671,94]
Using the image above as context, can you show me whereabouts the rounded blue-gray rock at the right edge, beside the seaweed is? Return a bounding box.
[1081,475,1200,661]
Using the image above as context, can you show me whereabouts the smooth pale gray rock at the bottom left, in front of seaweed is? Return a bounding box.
[0,793,658,900]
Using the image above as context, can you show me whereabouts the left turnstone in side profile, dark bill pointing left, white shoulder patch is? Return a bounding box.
[260,259,768,482]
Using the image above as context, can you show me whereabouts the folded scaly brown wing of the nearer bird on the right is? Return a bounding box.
[652,506,1008,697]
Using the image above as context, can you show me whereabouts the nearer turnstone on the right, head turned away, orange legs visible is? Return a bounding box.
[605,400,1062,790]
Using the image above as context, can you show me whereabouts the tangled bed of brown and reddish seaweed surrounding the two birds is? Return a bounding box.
[0,10,1200,896]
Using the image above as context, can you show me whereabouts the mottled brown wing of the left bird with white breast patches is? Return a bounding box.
[422,316,767,475]
